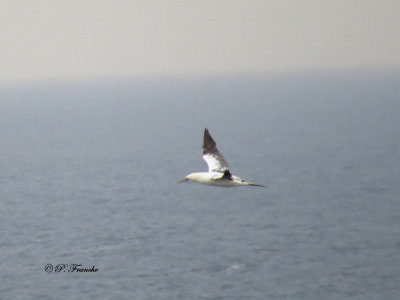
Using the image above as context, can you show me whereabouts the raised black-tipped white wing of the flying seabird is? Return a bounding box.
[203,128,228,172]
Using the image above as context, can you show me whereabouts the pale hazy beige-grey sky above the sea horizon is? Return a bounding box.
[0,0,400,82]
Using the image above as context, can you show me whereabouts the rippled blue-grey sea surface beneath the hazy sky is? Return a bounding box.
[0,71,400,300]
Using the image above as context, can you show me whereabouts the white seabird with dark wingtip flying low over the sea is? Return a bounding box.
[178,128,263,187]
